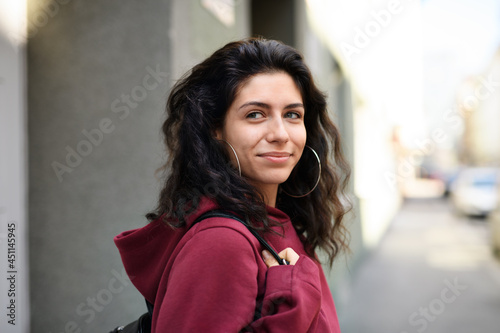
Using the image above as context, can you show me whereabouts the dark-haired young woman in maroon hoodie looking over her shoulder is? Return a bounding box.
[115,39,349,333]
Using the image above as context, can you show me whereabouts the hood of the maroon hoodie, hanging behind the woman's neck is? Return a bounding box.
[114,198,290,303]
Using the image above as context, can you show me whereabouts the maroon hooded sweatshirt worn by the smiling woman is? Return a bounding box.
[115,199,340,333]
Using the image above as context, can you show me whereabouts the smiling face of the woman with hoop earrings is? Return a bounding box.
[217,72,306,197]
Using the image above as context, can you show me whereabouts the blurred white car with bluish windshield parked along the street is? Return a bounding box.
[450,167,500,216]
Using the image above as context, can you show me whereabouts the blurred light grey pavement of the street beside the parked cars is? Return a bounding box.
[336,199,500,333]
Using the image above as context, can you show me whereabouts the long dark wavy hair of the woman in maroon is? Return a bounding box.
[146,38,350,265]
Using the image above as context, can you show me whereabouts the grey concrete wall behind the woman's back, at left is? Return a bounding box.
[28,0,249,332]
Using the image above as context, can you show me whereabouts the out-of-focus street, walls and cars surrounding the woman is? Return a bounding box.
[0,0,500,333]
